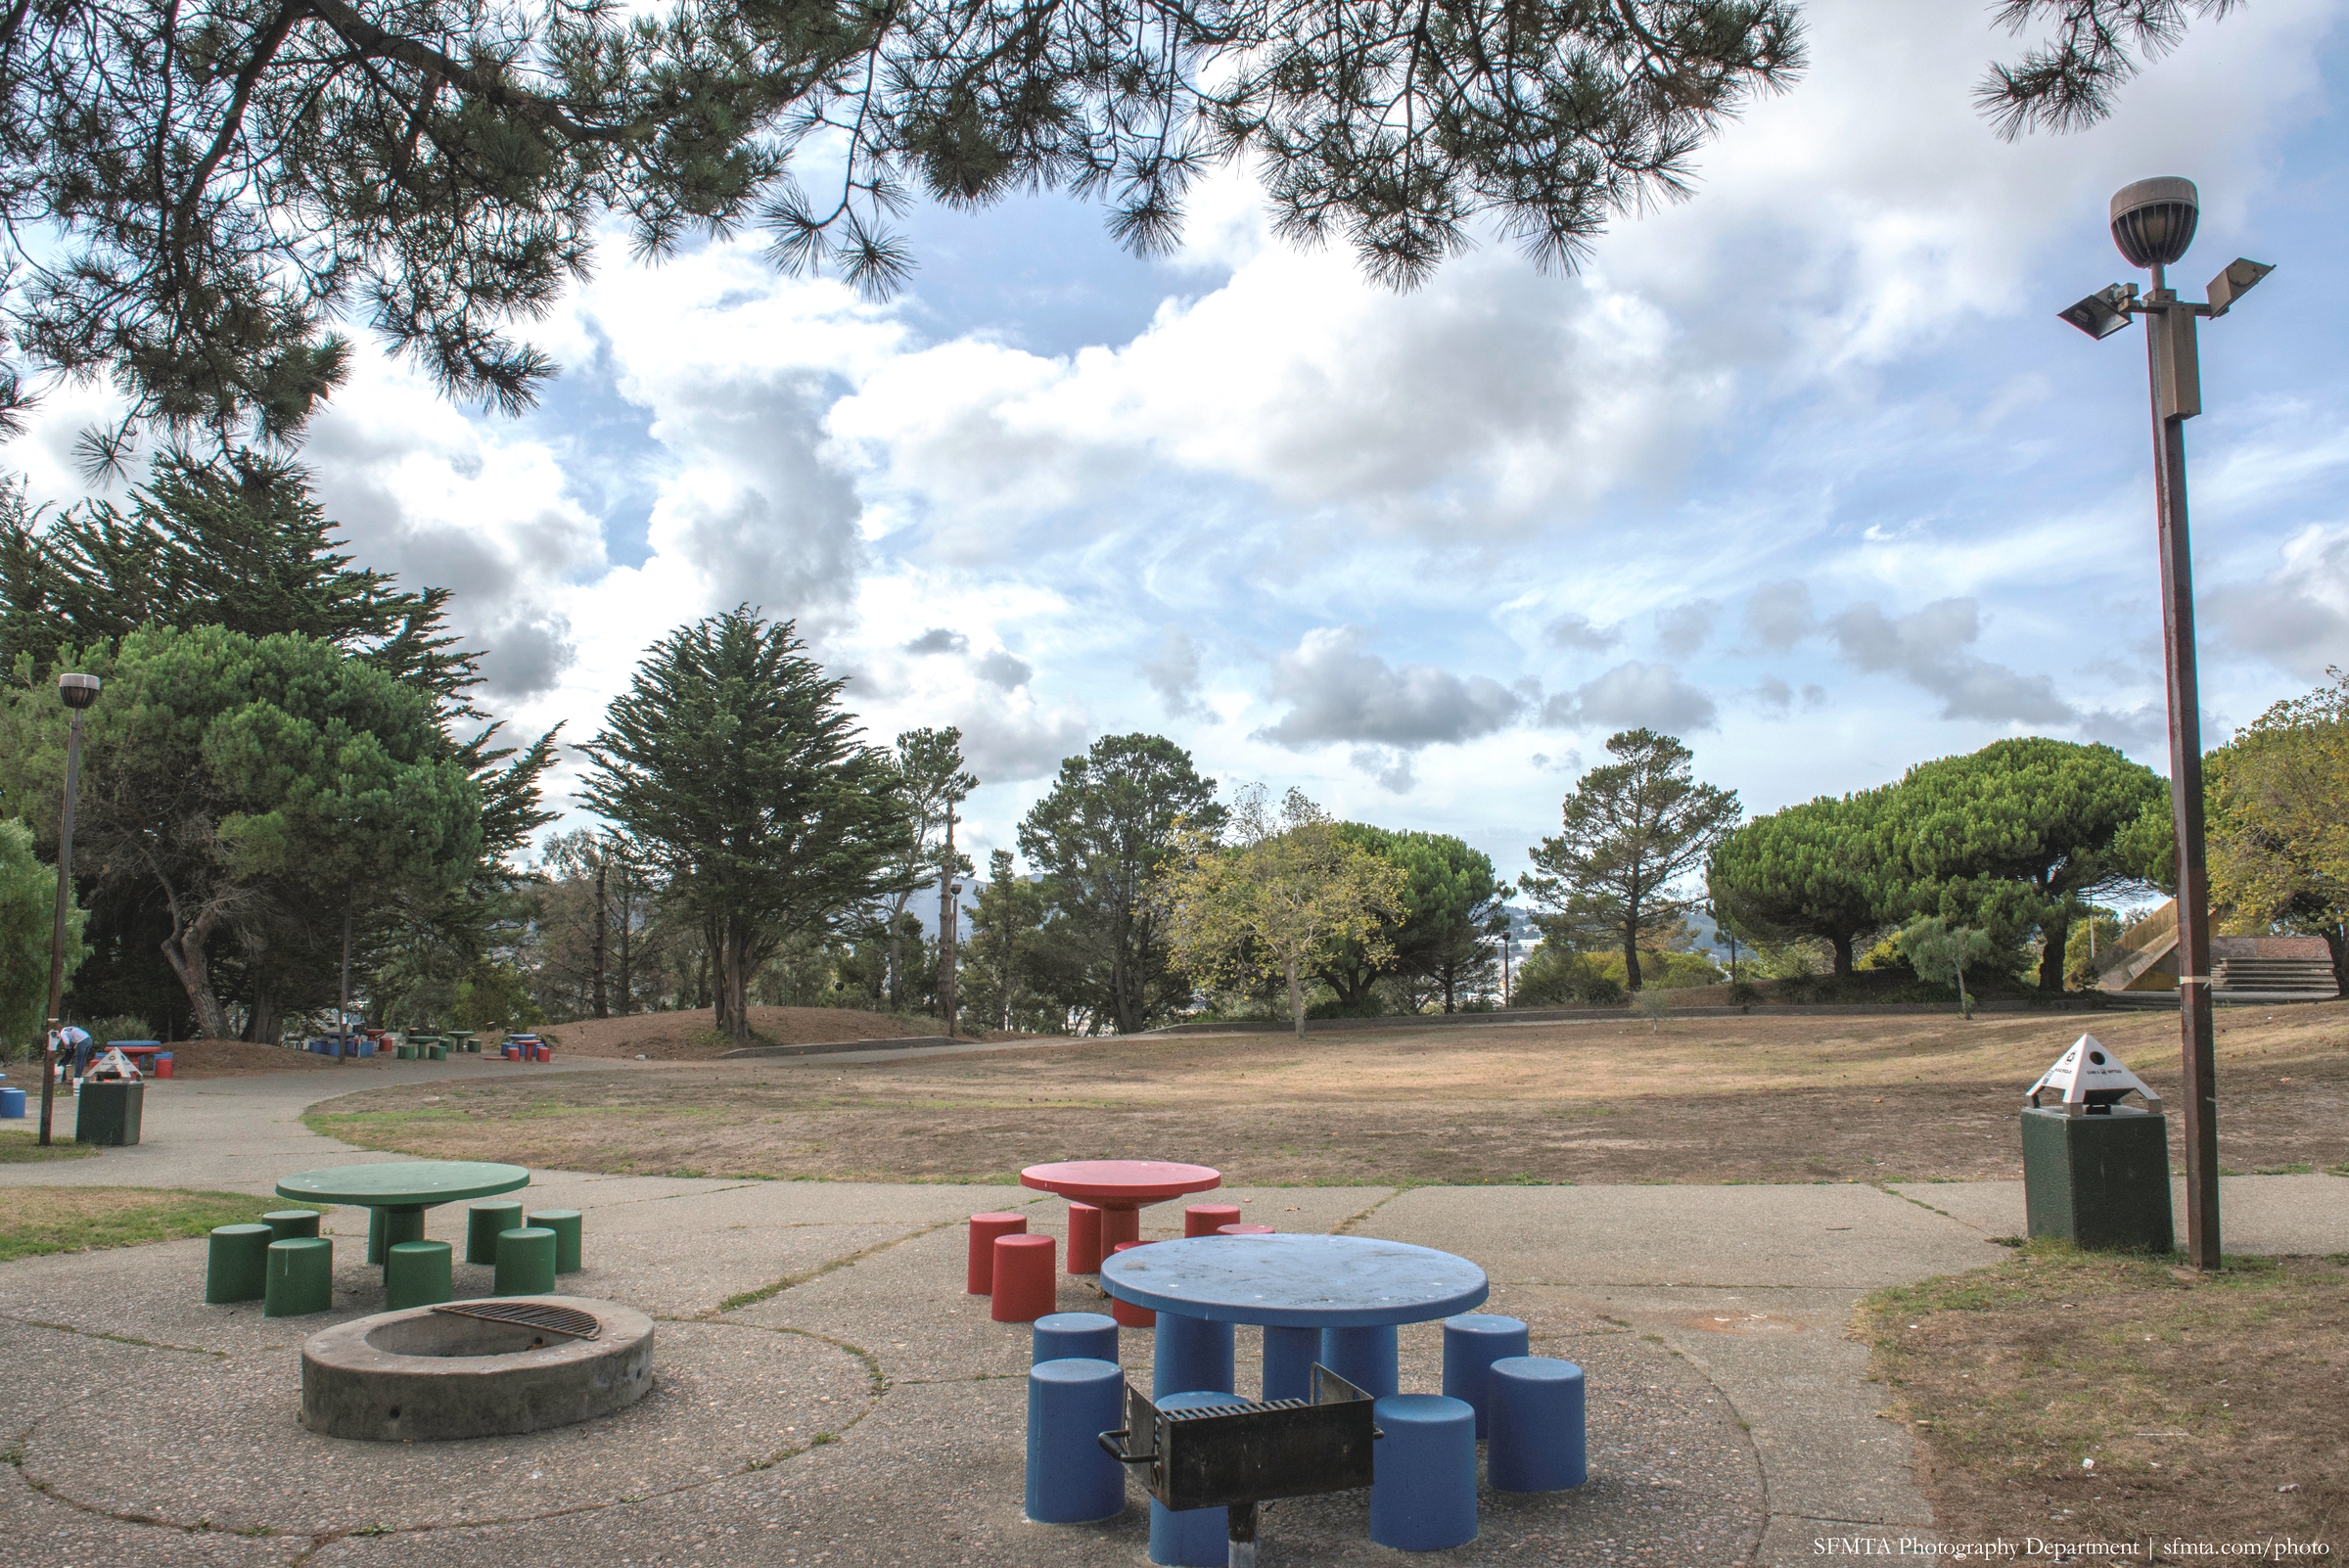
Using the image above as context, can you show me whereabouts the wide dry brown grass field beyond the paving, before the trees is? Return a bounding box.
[310,1002,2349,1185]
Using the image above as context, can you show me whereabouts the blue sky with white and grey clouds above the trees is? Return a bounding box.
[0,0,2349,876]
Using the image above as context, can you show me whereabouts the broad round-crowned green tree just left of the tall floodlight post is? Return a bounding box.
[1877,735,2168,991]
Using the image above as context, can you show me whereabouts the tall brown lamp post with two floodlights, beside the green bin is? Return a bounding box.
[2057,178,2274,1268]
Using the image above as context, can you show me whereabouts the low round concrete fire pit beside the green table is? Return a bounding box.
[300,1296,653,1444]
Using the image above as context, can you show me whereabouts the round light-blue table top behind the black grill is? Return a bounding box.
[1102,1234,1492,1328]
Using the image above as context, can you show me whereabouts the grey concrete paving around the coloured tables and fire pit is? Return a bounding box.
[0,1061,2349,1568]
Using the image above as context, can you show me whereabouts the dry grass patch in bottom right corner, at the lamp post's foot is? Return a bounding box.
[1863,1244,2349,1563]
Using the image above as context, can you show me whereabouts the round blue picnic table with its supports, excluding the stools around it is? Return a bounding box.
[1102,1234,1492,1399]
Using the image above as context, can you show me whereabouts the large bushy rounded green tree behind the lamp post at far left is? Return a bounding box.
[0,626,482,1038]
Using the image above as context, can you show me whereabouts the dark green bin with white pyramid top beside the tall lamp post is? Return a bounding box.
[2022,1036,2178,1251]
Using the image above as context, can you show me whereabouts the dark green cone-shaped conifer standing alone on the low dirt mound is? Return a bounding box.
[580,606,904,1042]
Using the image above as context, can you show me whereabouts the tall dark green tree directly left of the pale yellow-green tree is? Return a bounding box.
[1020,735,1223,1036]
